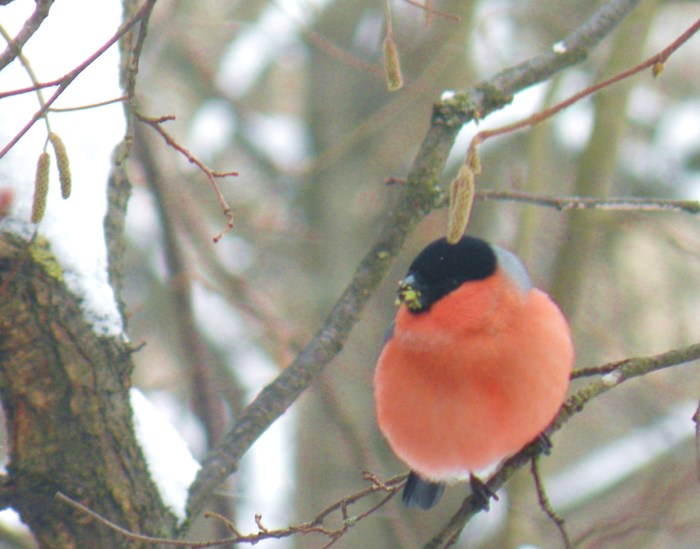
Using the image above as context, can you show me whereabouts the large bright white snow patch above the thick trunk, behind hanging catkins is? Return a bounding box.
[0,0,124,336]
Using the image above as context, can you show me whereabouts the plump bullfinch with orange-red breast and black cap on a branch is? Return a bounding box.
[373,236,574,509]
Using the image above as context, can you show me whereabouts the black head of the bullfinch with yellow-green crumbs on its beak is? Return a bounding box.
[397,236,497,313]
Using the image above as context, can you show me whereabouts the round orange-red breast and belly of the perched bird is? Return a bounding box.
[374,272,574,480]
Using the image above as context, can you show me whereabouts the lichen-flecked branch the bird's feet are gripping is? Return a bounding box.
[424,343,700,549]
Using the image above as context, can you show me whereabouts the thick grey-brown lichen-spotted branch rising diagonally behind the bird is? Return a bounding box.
[183,0,638,530]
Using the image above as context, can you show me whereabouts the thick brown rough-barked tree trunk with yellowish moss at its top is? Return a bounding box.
[0,233,175,548]
